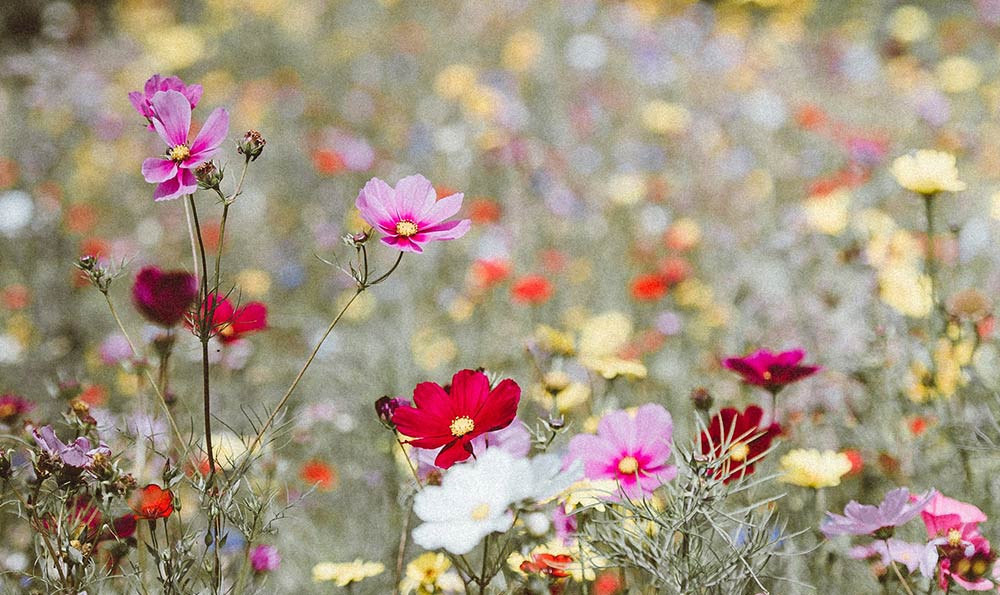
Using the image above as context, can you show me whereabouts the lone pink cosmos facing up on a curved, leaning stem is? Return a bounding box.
[354,175,472,252]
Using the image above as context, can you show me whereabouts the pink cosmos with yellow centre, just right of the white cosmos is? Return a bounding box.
[567,403,677,498]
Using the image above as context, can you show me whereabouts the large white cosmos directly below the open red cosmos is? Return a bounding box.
[413,448,582,555]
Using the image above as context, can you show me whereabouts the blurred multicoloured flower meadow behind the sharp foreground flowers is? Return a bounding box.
[0,0,1000,592]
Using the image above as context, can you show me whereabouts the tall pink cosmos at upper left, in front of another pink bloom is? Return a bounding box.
[142,91,229,200]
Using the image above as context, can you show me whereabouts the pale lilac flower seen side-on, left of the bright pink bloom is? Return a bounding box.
[820,488,936,539]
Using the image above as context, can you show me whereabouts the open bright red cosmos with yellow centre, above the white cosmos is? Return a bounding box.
[392,370,521,469]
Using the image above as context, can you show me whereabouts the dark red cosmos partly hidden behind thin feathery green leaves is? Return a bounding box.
[701,405,781,483]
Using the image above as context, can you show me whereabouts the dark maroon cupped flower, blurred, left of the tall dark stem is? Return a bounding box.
[132,266,198,327]
